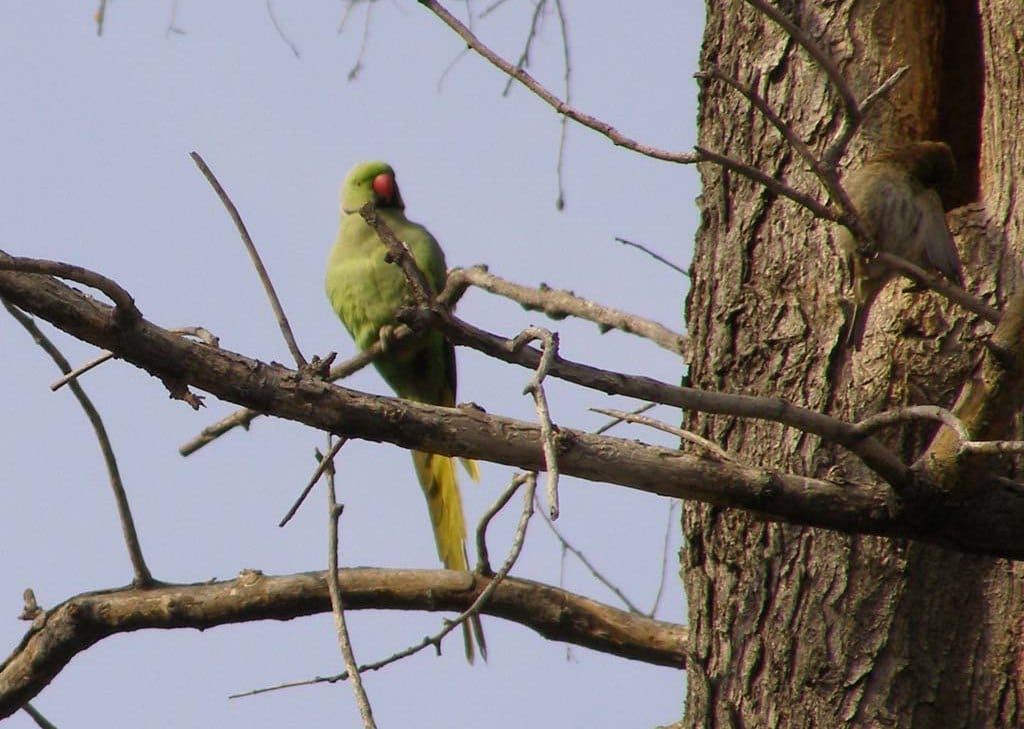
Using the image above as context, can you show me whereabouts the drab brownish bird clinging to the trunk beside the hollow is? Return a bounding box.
[839,141,964,349]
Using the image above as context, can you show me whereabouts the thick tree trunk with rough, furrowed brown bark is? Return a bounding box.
[682,0,1024,727]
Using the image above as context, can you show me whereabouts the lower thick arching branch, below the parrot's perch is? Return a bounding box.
[0,568,686,718]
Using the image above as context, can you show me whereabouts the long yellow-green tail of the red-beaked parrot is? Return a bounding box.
[413,451,487,663]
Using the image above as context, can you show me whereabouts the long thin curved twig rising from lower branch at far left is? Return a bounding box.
[3,301,154,587]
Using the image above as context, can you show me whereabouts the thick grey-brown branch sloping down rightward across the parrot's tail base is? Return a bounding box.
[0,264,1024,558]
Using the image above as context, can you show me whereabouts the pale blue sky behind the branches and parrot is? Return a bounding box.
[0,0,703,728]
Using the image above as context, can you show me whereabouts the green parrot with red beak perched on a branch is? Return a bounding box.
[325,162,487,662]
